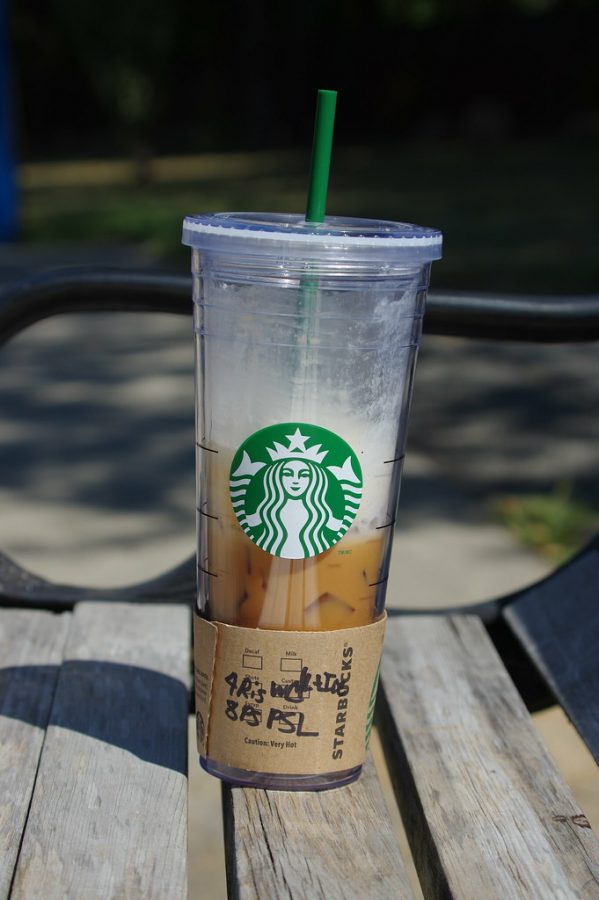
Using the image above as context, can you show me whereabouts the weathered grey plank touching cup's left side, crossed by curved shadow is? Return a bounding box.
[12,603,190,900]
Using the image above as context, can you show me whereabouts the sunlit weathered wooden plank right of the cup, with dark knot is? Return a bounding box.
[380,616,599,900]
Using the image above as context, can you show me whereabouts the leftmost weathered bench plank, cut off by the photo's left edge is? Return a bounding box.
[0,609,70,898]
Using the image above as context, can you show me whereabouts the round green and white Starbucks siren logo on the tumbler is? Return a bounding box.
[229,422,362,559]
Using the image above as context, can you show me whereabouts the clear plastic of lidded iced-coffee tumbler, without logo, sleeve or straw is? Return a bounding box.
[184,214,441,789]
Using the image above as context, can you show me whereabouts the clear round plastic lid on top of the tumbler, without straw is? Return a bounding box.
[183,212,443,263]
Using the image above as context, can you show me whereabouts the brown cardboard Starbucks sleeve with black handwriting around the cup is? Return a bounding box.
[194,613,386,775]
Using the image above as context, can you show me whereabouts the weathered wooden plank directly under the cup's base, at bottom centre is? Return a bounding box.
[223,758,413,900]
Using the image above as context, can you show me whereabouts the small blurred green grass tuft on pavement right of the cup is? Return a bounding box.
[494,484,599,565]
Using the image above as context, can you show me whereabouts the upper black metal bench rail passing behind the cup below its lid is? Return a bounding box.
[0,267,599,343]
